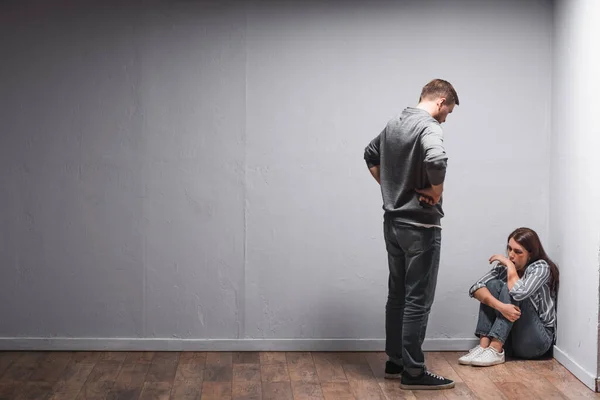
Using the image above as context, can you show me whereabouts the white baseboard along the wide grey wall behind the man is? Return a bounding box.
[0,337,477,351]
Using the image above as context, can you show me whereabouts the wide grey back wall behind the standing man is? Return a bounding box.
[0,0,552,348]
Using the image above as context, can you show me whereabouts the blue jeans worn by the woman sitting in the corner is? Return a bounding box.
[475,279,554,359]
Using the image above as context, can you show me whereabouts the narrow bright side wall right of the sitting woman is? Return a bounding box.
[550,0,600,388]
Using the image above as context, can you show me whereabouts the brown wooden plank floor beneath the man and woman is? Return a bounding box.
[0,352,600,400]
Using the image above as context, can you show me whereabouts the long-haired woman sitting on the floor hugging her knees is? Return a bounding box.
[458,228,558,367]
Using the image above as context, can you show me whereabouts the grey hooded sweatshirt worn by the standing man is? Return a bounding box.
[364,107,448,226]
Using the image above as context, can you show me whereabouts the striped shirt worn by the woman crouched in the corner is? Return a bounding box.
[469,260,556,328]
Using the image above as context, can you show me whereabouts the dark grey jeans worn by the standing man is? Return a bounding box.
[384,218,442,376]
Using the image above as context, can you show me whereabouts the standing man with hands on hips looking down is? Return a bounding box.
[364,79,459,390]
